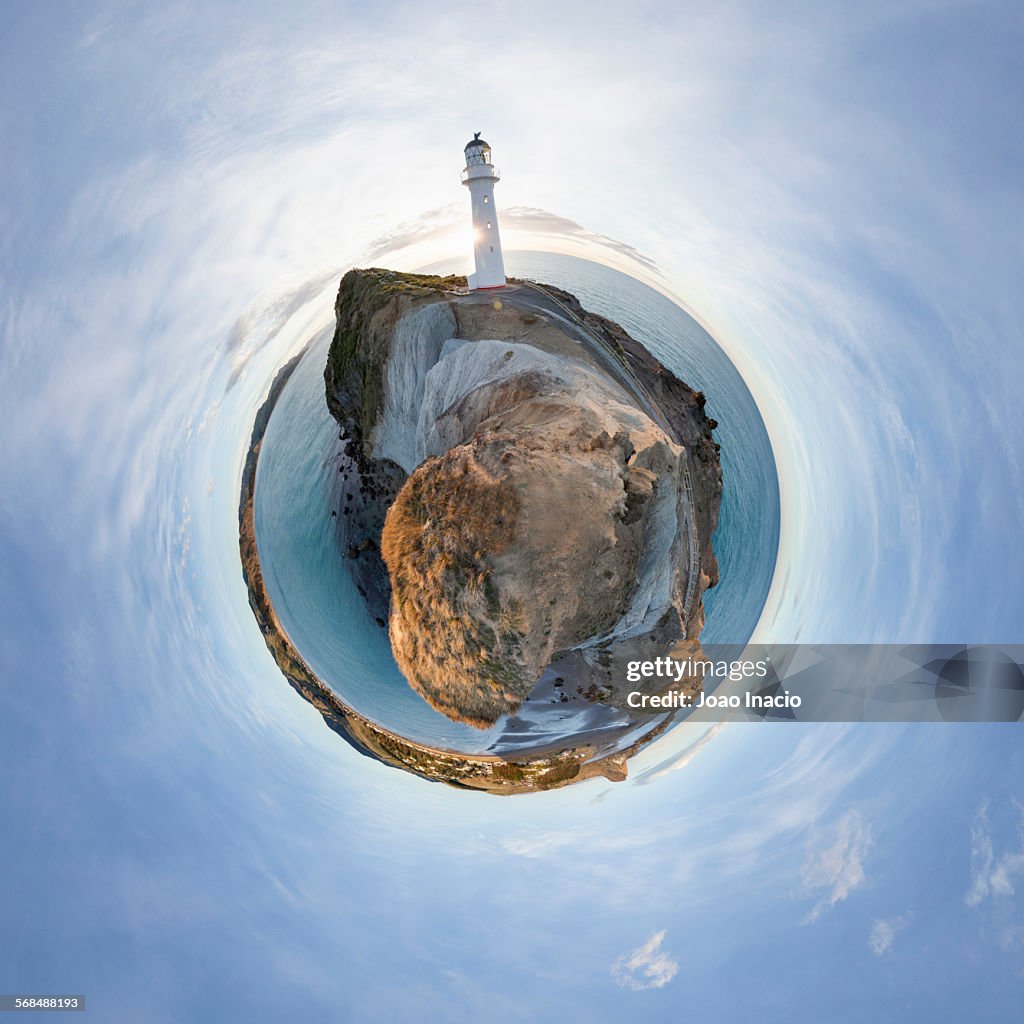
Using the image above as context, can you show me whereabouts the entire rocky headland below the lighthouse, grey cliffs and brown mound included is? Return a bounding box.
[326,271,721,728]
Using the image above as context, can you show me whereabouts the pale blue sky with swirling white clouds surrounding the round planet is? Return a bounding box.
[0,0,1024,1021]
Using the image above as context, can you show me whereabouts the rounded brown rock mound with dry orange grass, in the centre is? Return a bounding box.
[383,358,682,726]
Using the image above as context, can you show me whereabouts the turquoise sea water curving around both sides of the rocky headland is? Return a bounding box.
[256,253,779,751]
